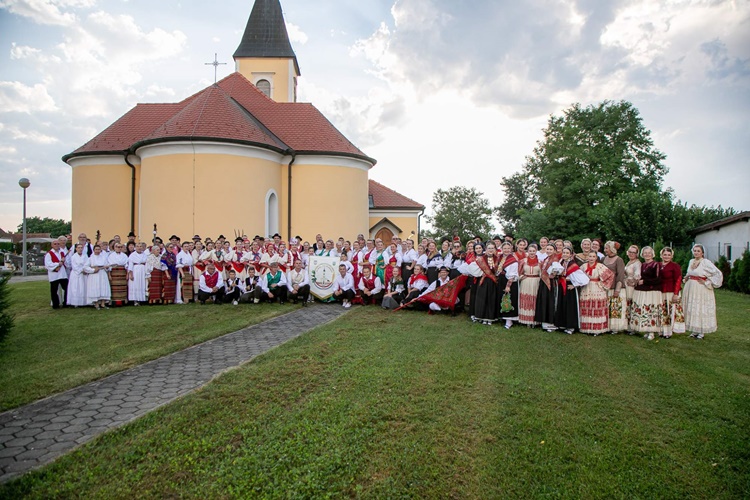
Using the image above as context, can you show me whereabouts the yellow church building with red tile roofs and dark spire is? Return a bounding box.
[63,0,425,241]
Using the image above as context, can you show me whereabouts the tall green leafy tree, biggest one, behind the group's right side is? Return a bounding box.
[498,101,667,238]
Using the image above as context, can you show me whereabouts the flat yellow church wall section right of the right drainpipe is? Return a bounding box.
[290,157,369,243]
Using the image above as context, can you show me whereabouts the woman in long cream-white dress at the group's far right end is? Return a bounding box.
[684,244,724,339]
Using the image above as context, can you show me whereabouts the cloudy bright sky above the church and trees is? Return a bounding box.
[0,0,750,234]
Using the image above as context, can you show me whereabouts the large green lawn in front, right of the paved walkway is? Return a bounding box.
[0,292,750,499]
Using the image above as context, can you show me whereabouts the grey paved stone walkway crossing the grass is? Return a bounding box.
[0,304,346,482]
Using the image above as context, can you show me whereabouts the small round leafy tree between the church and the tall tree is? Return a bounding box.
[427,186,493,241]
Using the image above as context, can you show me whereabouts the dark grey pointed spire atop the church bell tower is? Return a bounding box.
[238,0,300,74]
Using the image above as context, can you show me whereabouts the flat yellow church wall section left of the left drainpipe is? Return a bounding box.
[69,156,137,241]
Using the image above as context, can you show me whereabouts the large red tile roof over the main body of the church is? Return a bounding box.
[63,73,375,164]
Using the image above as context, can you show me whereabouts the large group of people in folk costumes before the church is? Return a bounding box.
[45,233,722,339]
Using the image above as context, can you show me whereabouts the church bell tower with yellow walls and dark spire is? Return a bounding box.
[233,0,300,102]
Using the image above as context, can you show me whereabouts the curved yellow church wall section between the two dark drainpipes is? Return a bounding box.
[138,144,282,240]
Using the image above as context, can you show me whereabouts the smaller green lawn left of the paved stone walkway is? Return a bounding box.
[0,281,297,411]
